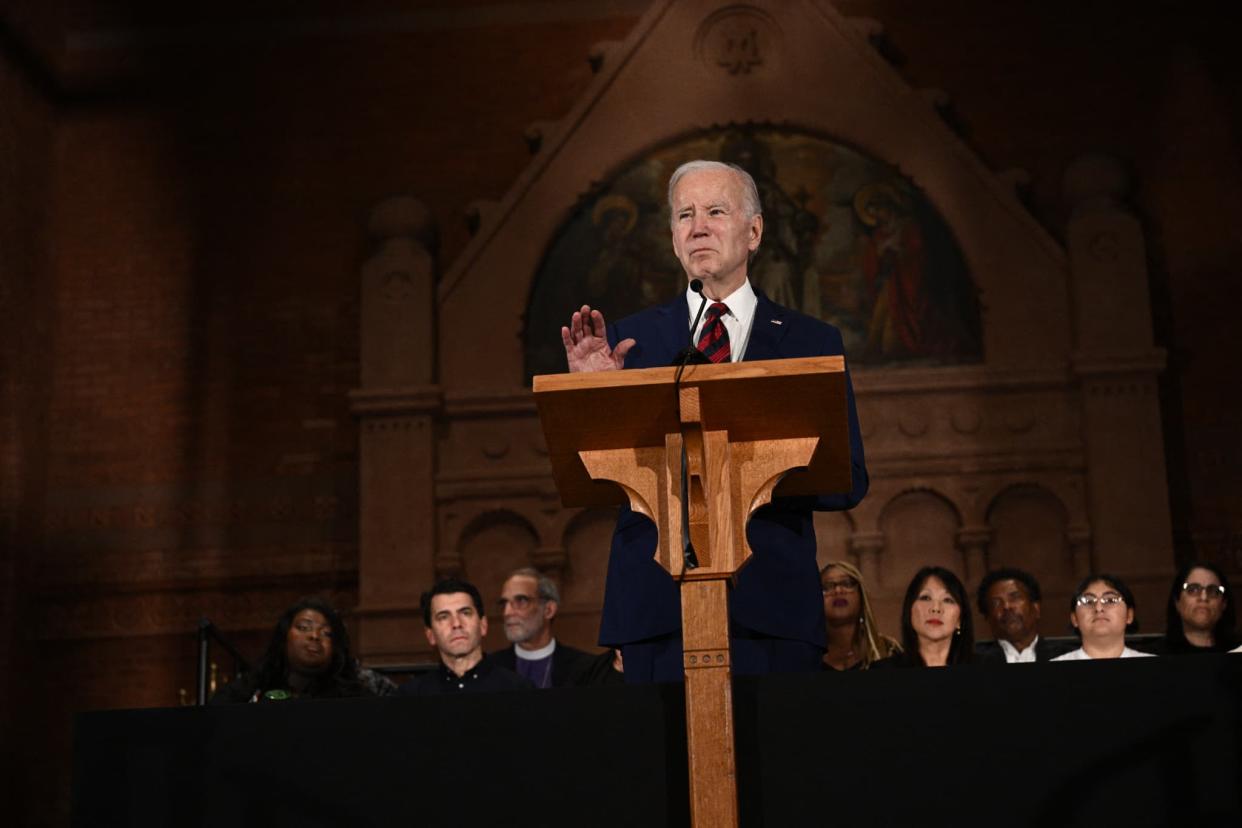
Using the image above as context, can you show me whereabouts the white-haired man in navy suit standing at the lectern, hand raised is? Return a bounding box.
[561,161,867,682]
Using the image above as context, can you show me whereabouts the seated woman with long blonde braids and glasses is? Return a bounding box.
[820,561,902,670]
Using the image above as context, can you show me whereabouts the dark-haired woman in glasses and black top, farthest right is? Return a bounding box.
[1161,561,1240,655]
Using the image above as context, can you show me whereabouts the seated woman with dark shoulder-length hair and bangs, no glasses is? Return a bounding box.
[876,566,975,667]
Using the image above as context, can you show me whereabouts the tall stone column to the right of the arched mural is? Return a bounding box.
[1064,156,1174,628]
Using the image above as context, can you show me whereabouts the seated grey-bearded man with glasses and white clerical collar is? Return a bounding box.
[492,566,596,688]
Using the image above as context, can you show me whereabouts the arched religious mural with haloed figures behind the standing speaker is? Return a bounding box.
[525,125,984,377]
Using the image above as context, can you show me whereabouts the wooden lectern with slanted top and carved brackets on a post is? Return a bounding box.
[534,356,851,827]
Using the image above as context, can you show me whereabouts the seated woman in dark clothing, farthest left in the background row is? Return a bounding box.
[211,597,368,704]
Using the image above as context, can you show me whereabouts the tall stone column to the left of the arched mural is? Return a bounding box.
[350,196,442,663]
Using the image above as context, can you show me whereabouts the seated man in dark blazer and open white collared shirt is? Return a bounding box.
[975,569,1072,664]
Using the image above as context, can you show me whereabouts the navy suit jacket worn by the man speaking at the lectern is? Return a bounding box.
[600,290,867,648]
